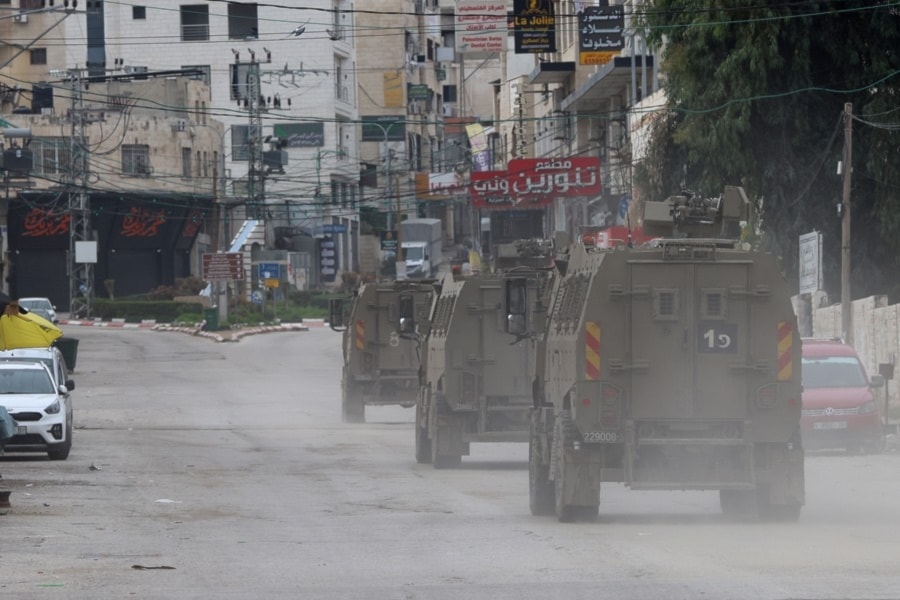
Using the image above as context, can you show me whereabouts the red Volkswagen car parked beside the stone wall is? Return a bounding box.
[800,339,884,452]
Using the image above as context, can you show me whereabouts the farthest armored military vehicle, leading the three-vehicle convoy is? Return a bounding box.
[329,280,435,423]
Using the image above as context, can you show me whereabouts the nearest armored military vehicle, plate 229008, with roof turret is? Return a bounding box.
[529,187,804,521]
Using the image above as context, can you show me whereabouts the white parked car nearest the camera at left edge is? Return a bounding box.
[0,361,73,460]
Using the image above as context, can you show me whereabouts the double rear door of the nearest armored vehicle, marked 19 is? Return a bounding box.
[630,261,753,419]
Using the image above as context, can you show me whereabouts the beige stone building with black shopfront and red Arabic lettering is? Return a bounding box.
[0,2,223,310]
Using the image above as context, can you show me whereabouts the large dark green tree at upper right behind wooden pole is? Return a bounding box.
[635,0,900,297]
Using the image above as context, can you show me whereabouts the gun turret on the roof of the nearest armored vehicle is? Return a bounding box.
[643,186,750,240]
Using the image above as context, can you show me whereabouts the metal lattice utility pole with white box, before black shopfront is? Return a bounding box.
[67,68,97,318]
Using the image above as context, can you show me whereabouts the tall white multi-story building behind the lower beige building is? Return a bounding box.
[0,0,359,298]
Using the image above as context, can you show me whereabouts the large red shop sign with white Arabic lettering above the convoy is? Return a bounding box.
[470,156,602,208]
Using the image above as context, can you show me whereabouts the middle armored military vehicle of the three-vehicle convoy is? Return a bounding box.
[415,244,553,468]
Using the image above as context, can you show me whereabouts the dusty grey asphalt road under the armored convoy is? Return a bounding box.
[0,328,900,600]
